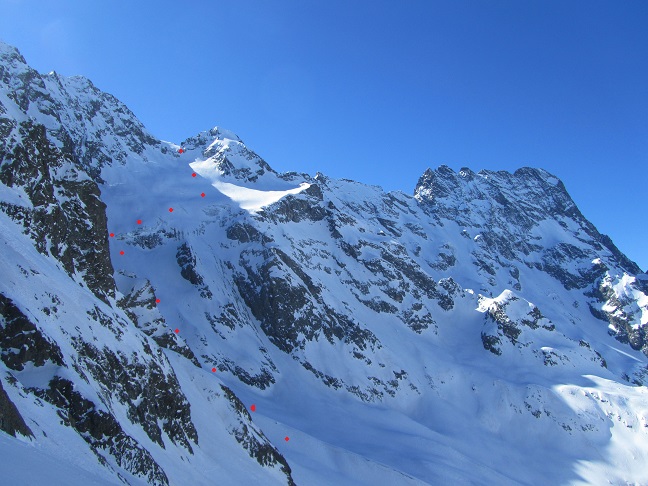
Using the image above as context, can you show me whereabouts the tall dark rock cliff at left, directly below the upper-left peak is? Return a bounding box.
[0,123,115,303]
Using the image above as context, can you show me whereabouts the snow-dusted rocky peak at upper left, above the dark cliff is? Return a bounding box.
[0,43,161,178]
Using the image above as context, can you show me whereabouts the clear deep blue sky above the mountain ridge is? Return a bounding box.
[0,0,648,270]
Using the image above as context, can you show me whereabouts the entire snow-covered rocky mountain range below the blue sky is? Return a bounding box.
[0,44,648,485]
